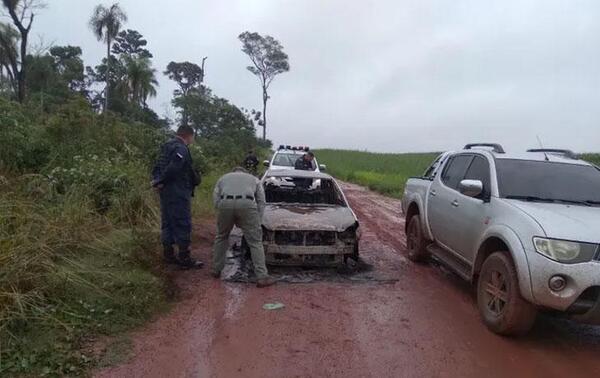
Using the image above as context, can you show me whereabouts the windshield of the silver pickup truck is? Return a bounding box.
[496,159,600,206]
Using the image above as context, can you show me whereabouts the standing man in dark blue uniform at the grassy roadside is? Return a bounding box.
[152,126,204,268]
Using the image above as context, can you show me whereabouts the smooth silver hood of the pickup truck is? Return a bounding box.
[507,200,600,243]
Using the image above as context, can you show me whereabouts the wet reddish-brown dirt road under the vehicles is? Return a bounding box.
[97,184,600,378]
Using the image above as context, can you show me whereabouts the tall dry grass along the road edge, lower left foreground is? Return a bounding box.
[0,175,165,376]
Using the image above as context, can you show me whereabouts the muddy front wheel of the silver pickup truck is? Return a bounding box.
[477,251,537,336]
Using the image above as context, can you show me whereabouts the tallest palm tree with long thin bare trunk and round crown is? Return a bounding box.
[90,3,127,112]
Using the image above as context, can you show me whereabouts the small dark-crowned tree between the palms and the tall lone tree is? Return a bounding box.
[164,58,206,125]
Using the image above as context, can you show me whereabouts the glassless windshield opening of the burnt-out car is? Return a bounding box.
[264,177,346,207]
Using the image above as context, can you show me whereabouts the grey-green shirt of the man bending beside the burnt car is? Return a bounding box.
[213,172,266,216]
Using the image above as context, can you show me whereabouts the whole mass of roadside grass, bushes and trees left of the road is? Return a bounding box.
[0,0,270,376]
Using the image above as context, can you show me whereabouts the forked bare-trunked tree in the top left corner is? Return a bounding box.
[2,0,45,103]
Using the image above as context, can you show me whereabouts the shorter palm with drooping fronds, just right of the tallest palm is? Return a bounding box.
[123,56,158,107]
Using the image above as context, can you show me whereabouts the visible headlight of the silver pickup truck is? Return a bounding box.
[533,237,598,264]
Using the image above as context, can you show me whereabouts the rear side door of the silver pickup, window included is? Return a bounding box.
[427,154,473,251]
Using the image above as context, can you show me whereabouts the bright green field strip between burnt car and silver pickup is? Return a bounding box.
[314,150,438,198]
